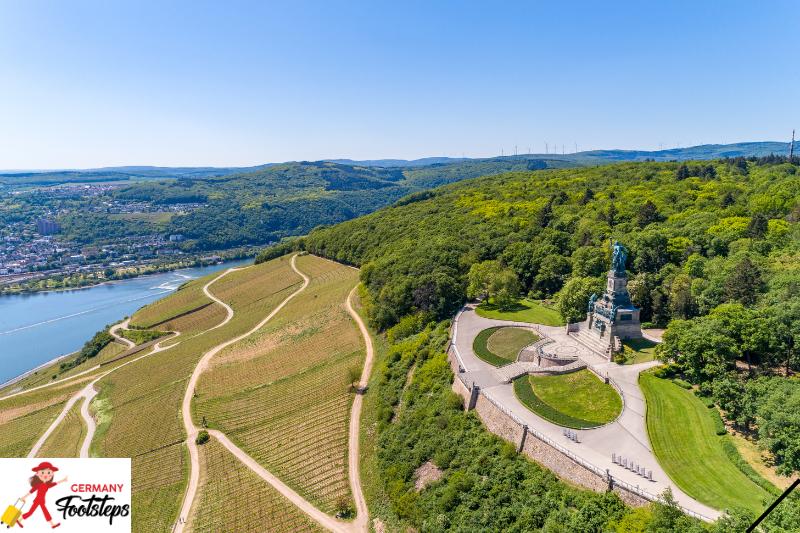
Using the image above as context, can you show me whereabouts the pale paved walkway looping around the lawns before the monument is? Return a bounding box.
[453,305,721,519]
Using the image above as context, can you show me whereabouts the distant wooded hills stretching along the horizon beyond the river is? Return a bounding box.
[0,142,788,251]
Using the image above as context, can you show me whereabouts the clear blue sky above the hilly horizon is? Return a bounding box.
[0,0,800,169]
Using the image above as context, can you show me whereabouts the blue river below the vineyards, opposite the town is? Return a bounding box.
[0,259,253,383]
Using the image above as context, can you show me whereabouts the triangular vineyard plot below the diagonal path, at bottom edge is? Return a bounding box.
[186,437,323,533]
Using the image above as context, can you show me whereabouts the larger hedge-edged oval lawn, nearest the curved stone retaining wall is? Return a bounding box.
[514,369,622,429]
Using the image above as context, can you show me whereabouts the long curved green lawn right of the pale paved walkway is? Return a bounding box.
[639,372,773,514]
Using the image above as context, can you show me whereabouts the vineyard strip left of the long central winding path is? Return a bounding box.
[92,258,301,531]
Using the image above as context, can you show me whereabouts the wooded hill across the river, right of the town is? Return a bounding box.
[47,159,569,252]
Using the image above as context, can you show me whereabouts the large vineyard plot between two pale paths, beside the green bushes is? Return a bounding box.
[194,256,364,513]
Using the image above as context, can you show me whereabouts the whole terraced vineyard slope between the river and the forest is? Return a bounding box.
[0,256,366,531]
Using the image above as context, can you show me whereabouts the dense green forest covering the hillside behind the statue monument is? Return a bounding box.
[296,156,800,486]
